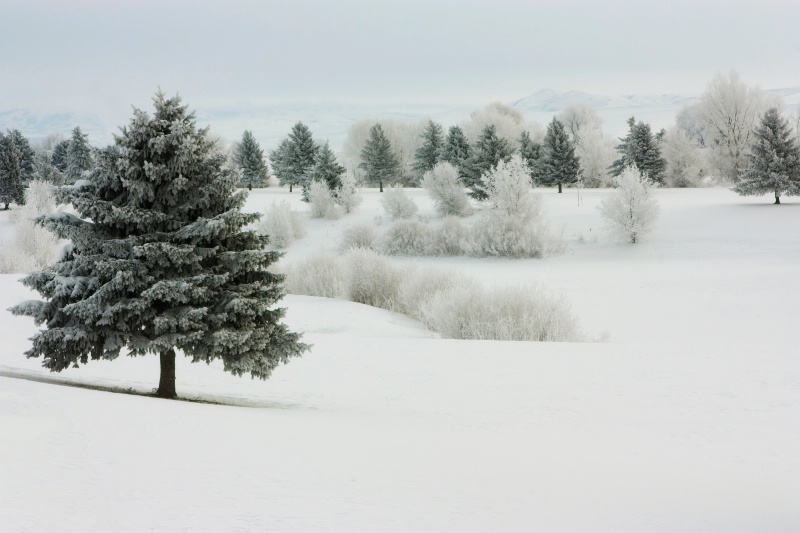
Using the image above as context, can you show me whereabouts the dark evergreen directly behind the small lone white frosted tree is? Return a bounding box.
[609,117,667,185]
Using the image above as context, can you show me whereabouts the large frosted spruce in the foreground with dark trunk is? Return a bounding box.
[11,93,308,397]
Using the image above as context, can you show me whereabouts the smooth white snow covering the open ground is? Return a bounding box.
[0,189,800,531]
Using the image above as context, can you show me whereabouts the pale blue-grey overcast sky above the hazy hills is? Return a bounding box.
[0,0,800,121]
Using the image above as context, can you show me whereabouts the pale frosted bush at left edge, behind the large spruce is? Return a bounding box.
[0,180,58,273]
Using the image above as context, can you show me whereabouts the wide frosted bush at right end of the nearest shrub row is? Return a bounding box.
[422,284,581,342]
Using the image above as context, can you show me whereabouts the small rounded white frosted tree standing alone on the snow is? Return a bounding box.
[598,166,659,244]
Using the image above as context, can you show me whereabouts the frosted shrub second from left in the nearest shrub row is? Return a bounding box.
[344,249,402,310]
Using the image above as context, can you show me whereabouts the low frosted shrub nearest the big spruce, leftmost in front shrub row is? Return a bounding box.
[284,252,347,298]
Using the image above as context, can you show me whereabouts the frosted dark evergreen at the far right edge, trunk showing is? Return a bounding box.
[733,107,800,204]
